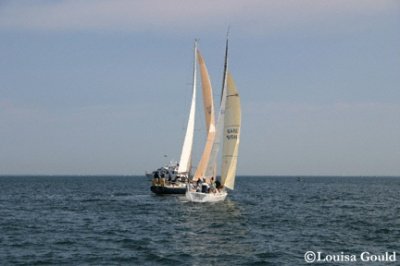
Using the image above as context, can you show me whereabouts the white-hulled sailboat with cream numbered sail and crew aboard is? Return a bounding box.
[185,39,241,202]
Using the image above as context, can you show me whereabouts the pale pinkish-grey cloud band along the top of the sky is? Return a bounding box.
[0,0,395,32]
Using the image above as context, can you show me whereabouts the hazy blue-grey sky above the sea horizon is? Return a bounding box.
[0,0,400,176]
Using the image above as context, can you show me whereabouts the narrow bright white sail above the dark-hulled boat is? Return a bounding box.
[178,41,197,175]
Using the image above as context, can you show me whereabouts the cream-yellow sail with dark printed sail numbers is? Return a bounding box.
[221,73,241,189]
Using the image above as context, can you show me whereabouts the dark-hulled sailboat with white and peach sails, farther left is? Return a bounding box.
[151,41,215,194]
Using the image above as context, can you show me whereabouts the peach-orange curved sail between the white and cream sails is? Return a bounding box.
[193,48,215,180]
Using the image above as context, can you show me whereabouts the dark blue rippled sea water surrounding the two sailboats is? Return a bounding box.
[0,176,400,265]
